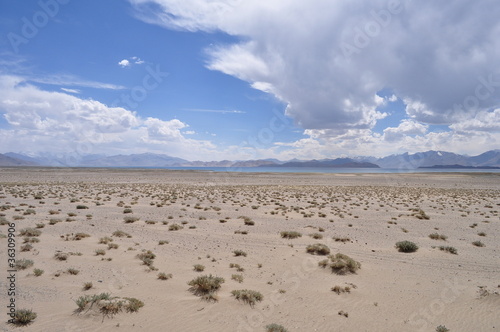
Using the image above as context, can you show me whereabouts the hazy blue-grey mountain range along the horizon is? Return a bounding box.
[0,149,500,169]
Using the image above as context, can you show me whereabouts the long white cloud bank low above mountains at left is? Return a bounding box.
[0,75,215,157]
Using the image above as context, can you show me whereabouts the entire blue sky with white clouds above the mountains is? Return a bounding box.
[0,0,500,160]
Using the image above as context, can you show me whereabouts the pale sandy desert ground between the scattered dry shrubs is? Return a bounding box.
[0,168,500,332]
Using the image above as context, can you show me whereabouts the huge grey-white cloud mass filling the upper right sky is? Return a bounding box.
[129,0,500,131]
